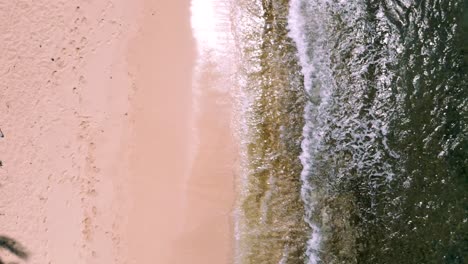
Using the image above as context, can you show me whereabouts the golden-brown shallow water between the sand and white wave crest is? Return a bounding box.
[233,1,310,263]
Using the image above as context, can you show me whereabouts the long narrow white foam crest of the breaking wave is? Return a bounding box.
[288,0,335,264]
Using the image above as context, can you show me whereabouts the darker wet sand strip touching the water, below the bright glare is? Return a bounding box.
[174,63,237,263]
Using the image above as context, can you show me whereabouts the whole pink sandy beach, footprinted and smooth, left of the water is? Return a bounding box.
[0,0,235,264]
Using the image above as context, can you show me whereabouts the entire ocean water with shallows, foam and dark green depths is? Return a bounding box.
[192,0,468,264]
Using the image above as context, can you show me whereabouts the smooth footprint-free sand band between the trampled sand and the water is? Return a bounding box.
[129,1,235,264]
